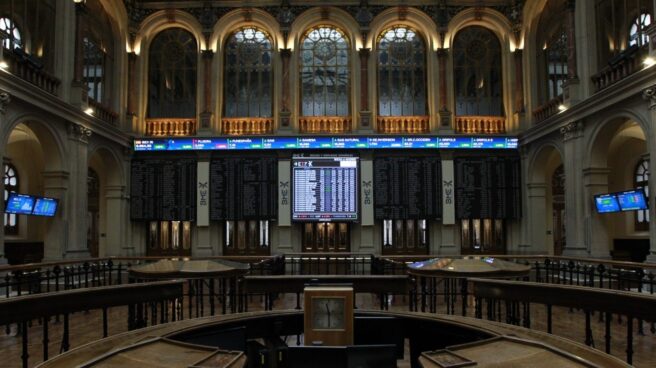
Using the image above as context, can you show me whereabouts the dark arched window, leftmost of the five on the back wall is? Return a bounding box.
[148,28,198,118]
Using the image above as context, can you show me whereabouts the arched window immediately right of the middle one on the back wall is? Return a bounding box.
[377,26,427,116]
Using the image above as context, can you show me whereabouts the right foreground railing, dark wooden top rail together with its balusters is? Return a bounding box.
[469,279,656,364]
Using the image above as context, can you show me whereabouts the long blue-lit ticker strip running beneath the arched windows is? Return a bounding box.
[134,136,518,152]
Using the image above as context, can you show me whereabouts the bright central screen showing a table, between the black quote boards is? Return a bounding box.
[292,156,359,221]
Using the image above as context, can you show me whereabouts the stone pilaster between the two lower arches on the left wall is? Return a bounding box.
[65,123,91,258]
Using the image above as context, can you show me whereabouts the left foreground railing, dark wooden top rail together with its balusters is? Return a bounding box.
[0,281,183,368]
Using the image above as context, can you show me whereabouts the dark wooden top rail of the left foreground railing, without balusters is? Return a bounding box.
[0,281,184,325]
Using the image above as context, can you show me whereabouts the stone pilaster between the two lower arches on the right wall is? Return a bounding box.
[560,120,589,256]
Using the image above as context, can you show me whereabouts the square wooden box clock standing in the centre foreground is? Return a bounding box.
[304,286,353,346]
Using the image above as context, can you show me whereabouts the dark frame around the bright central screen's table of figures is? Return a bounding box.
[291,154,360,223]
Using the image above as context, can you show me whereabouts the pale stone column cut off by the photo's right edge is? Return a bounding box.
[642,84,656,263]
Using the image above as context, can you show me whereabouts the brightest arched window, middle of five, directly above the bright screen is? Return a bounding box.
[300,25,350,116]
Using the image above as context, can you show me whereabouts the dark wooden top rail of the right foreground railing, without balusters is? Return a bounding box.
[469,278,656,321]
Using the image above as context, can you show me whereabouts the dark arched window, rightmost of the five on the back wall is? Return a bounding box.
[453,26,504,116]
